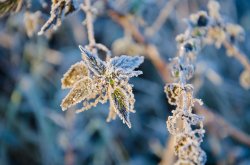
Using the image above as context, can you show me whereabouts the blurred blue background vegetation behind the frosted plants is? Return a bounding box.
[0,0,250,165]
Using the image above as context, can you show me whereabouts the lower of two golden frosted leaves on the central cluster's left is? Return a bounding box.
[61,78,92,110]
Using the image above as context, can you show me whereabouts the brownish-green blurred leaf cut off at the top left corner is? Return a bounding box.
[0,0,23,17]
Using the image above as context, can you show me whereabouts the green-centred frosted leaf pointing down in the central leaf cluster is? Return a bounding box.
[110,87,131,128]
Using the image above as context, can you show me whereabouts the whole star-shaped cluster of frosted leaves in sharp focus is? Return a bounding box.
[61,46,144,128]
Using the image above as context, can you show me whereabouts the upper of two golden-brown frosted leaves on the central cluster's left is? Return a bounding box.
[61,61,89,89]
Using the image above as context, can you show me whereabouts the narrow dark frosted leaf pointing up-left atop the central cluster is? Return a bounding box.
[79,46,106,75]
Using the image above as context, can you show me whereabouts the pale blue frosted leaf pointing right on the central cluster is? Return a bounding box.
[111,55,144,71]
